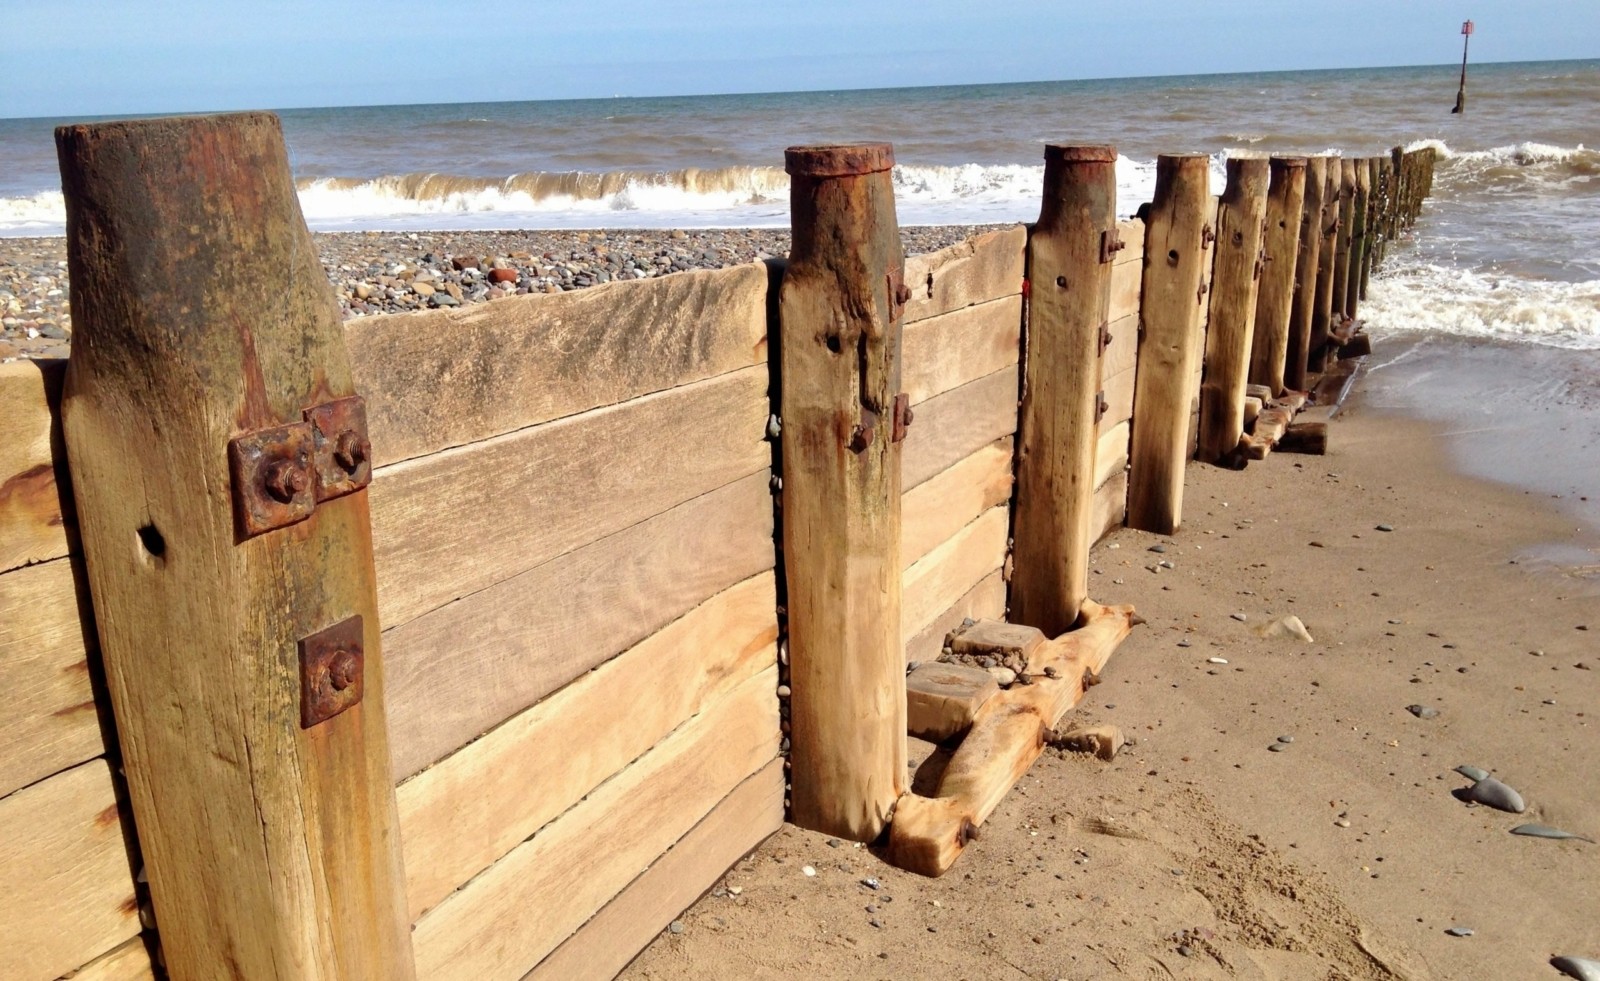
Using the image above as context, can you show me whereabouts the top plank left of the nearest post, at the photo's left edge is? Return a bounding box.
[0,362,70,571]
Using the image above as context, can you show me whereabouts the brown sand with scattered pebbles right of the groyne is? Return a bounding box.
[622,349,1600,981]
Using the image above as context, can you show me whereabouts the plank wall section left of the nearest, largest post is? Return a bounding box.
[0,362,152,981]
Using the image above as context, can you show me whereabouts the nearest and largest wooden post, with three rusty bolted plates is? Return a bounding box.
[56,114,413,981]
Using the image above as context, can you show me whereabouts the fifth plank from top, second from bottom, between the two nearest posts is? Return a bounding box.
[411,664,779,981]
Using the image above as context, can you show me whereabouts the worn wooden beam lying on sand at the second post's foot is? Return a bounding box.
[885,602,1142,875]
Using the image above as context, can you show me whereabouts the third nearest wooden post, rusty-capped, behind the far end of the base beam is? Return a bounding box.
[1011,146,1117,637]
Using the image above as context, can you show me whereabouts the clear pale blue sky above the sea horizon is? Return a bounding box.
[0,0,1600,117]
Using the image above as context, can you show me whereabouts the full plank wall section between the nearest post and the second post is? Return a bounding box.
[346,264,784,979]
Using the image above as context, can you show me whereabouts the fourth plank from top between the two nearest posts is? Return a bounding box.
[397,571,778,920]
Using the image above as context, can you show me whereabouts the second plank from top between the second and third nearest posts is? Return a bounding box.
[901,293,1022,405]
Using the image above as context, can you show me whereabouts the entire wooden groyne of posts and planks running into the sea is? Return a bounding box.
[0,104,1430,981]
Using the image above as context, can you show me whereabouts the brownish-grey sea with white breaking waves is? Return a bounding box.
[0,59,1600,528]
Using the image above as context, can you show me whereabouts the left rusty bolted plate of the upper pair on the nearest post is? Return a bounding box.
[227,422,317,538]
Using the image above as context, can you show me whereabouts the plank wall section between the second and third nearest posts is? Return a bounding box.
[901,227,1027,661]
